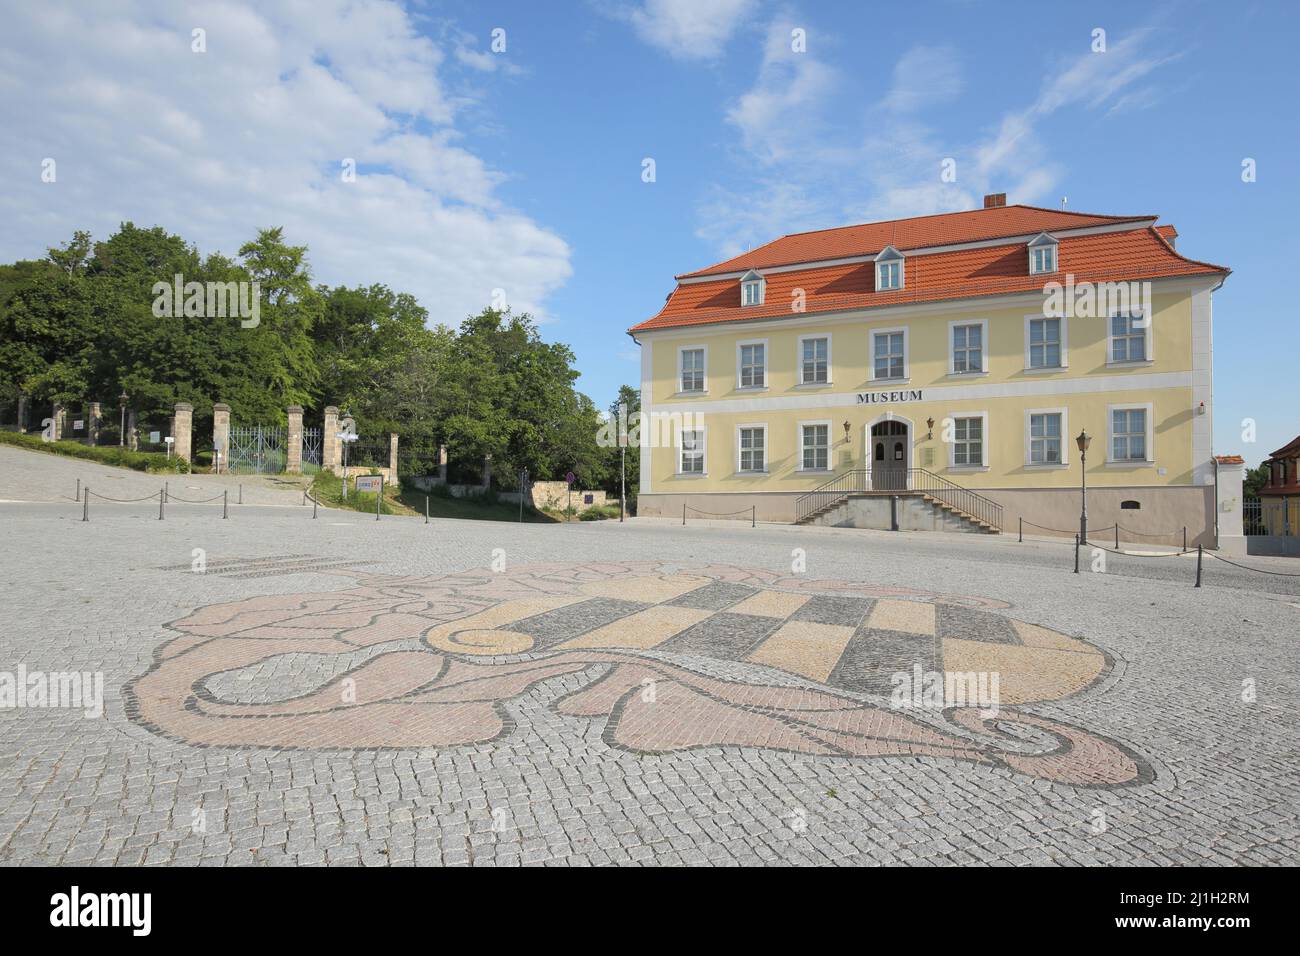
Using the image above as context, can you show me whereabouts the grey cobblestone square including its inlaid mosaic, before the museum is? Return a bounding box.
[0,452,1300,865]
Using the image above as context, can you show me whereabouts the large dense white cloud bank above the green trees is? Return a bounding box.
[0,0,571,323]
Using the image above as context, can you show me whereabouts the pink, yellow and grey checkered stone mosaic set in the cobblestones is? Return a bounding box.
[126,562,1152,787]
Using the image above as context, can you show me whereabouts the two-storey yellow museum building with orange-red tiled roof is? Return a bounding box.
[631,195,1229,545]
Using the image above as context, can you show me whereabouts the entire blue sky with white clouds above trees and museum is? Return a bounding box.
[0,0,1300,464]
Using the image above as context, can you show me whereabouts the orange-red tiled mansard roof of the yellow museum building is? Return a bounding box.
[631,206,1229,333]
